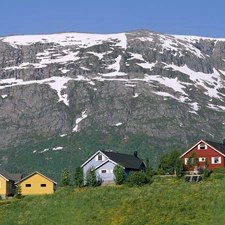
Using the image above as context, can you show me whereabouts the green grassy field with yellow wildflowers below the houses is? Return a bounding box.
[0,174,225,225]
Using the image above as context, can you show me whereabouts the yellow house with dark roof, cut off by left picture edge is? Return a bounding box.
[0,168,22,199]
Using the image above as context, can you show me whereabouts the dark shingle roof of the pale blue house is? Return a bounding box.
[101,151,143,170]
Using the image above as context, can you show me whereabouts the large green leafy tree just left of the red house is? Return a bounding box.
[158,148,181,174]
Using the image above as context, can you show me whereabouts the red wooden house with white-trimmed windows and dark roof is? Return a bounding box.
[180,140,225,172]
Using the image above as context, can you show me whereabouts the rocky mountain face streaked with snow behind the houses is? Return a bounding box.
[0,30,225,178]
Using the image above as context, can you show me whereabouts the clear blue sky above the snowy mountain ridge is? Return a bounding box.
[0,0,225,38]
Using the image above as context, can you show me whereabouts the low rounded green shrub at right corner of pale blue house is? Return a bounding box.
[126,171,151,187]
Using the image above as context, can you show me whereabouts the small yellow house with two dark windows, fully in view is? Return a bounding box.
[16,171,57,195]
